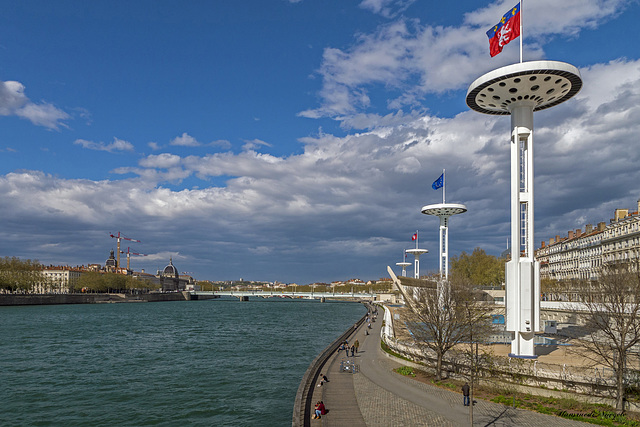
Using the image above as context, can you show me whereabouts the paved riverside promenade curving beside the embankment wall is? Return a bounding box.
[309,317,591,427]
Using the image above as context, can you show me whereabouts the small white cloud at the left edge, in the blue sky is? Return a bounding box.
[0,81,70,129]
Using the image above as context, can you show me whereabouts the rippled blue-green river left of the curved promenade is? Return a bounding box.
[0,298,365,426]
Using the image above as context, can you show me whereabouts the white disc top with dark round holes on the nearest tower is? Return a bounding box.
[467,61,582,115]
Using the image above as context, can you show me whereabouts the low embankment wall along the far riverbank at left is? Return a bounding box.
[0,292,196,306]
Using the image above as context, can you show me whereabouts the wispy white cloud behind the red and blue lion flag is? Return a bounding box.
[299,0,627,120]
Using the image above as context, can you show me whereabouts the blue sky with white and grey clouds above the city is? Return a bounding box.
[0,0,640,284]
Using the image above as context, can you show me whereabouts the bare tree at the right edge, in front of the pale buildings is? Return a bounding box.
[576,258,640,413]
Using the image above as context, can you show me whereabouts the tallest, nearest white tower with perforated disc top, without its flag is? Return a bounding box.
[467,61,582,358]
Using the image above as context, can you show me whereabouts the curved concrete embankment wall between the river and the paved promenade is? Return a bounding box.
[292,305,369,427]
